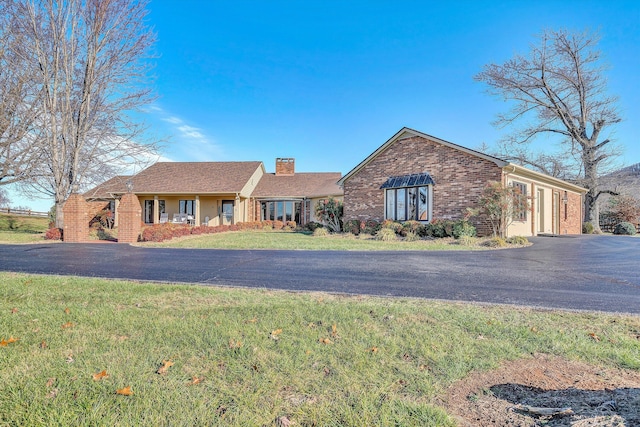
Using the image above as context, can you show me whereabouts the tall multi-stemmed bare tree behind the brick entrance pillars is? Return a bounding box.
[10,0,156,227]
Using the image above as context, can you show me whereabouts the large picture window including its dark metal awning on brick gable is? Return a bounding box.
[380,173,434,221]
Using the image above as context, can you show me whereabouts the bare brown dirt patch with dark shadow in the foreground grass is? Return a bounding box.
[443,355,640,427]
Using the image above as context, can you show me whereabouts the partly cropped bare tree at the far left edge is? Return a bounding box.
[0,0,40,185]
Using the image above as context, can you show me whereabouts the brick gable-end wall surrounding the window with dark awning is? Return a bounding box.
[344,136,502,234]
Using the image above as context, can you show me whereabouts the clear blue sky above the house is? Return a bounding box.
[7,0,640,210]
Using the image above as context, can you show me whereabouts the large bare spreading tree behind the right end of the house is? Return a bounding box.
[475,31,621,231]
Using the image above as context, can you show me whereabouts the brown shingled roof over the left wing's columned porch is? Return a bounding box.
[126,161,264,194]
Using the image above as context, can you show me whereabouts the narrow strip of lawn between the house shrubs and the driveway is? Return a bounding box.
[142,231,486,251]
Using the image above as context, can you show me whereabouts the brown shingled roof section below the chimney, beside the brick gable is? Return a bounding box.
[252,172,342,198]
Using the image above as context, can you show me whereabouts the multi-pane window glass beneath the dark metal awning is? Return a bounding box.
[385,186,430,221]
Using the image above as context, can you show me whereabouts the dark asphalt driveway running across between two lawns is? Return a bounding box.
[0,236,640,314]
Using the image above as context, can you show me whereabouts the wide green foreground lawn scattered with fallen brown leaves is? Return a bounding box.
[0,273,640,426]
